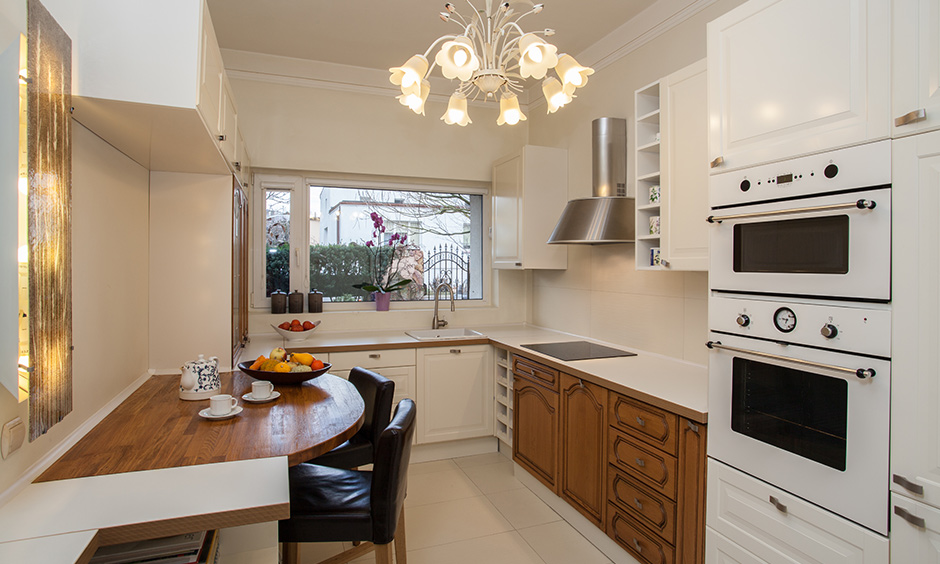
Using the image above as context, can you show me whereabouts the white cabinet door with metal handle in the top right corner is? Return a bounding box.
[891,0,940,137]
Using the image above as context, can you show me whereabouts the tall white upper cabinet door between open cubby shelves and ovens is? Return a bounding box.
[659,59,709,270]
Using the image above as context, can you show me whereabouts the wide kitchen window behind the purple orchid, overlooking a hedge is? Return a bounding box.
[253,175,484,308]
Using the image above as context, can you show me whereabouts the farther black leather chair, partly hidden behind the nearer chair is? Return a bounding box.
[307,366,395,468]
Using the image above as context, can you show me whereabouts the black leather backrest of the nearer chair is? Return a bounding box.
[371,399,417,544]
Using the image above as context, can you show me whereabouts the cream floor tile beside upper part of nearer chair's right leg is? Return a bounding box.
[405,496,512,552]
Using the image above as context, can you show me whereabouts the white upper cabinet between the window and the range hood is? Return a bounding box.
[492,145,568,270]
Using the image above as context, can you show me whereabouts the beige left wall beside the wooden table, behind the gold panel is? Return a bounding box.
[0,121,149,492]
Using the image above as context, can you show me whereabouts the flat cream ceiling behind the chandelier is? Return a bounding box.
[208,0,655,70]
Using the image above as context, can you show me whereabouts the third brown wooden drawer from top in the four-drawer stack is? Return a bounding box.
[607,466,676,544]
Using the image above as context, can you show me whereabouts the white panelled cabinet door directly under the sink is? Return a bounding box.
[415,345,493,444]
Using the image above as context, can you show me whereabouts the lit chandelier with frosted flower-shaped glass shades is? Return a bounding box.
[389,0,594,126]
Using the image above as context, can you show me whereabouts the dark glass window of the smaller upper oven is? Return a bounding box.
[733,215,849,274]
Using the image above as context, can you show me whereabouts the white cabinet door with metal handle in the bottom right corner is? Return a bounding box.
[891,494,940,564]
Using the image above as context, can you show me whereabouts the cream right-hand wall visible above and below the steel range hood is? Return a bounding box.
[528,0,743,364]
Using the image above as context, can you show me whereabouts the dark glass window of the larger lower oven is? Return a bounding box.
[731,358,849,471]
